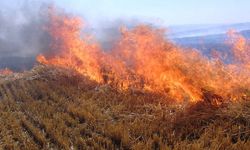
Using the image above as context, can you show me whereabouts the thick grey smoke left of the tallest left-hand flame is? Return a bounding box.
[0,0,51,70]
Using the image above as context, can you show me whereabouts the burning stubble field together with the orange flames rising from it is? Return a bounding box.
[0,6,250,150]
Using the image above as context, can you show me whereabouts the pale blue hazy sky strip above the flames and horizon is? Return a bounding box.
[55,0,250,25]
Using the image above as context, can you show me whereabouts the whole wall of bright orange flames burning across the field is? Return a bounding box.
[37,11,250,102]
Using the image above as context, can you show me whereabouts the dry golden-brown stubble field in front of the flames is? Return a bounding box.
[0,66,250,150]
